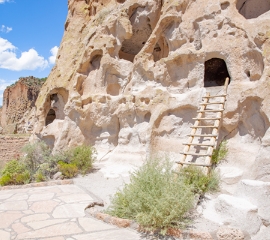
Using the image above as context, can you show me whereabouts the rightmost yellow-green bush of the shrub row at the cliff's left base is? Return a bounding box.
[69,145,95,174]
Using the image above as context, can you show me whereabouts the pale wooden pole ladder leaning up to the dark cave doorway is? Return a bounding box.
[176,78,229,174]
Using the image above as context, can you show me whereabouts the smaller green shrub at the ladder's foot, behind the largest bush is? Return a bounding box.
[180,166,219,194]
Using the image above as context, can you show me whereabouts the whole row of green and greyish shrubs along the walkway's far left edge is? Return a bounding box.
[0,142,95,186]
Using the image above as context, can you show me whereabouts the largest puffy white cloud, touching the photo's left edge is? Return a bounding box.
[0,37,48,71]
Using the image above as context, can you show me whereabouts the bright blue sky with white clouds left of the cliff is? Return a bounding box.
[0,0,68,106]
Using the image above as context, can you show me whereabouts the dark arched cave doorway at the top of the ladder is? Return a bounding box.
[204,58,230,87]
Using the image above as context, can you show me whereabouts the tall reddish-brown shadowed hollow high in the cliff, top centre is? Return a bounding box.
[119,7,152,62]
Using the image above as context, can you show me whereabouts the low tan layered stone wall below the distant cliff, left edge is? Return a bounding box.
[0,135,29,164]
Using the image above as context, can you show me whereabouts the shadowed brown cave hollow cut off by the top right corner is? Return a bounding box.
[236,0,270,19]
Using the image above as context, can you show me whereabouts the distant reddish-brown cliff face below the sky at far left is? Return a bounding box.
[1,76,43,133]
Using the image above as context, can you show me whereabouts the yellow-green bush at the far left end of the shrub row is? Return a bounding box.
[0,160,30,186]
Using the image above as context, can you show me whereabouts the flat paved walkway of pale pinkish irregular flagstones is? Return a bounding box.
[0,185,142,240]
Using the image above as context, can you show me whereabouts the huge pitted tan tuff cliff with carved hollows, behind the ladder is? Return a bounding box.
[32,0,270,239]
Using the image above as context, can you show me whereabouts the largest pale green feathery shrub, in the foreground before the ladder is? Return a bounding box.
[107,158,194,234]
